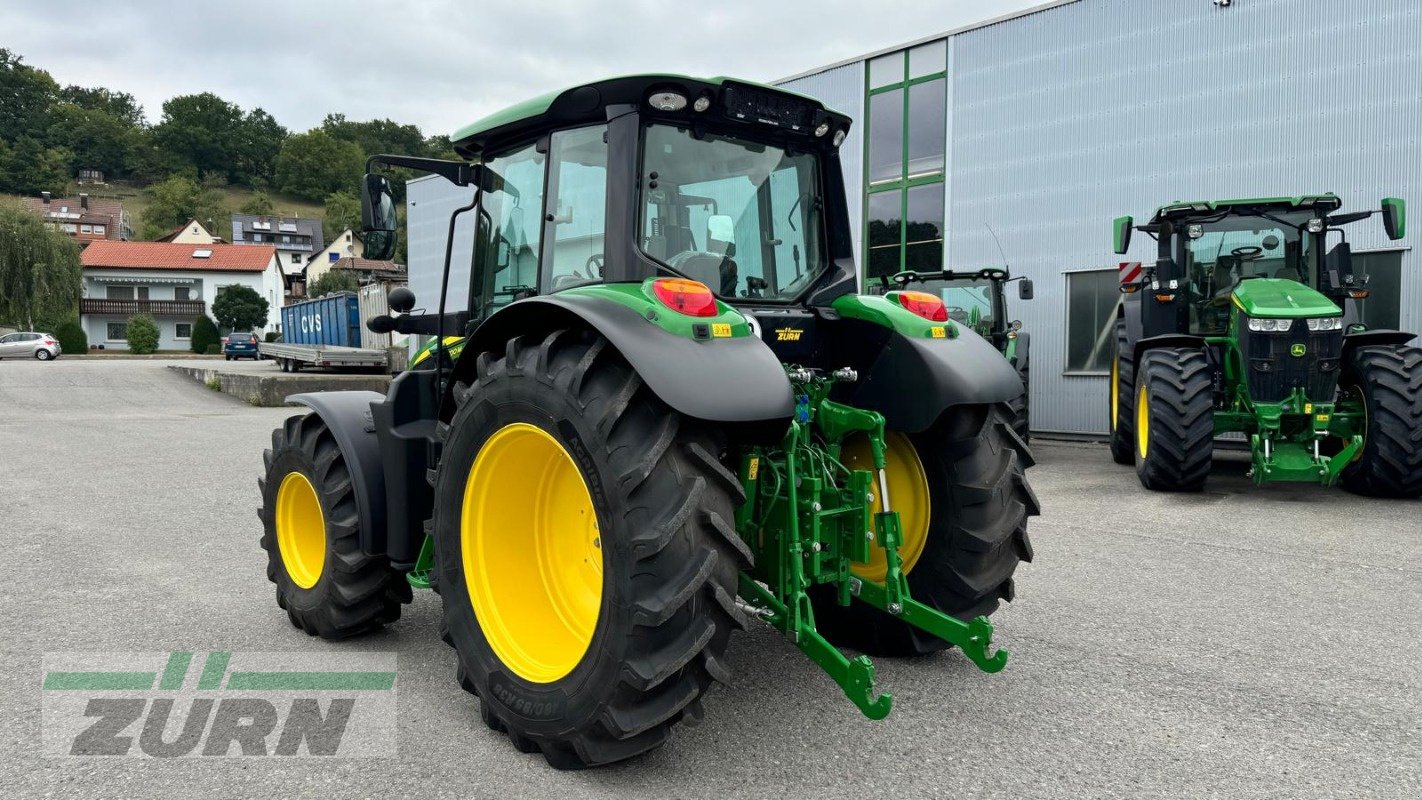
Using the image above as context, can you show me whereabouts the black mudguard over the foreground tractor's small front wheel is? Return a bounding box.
[286,392,385,554]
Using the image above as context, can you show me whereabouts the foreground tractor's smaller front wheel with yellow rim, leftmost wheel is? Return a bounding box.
[257,413,411,639]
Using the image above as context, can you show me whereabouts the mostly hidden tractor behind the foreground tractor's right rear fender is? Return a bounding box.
[869,267,1032,442]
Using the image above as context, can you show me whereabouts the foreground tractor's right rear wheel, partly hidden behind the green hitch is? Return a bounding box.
[811,404,1041,656]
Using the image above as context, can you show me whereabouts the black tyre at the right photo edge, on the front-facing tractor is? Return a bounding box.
[1340,345,1422,497]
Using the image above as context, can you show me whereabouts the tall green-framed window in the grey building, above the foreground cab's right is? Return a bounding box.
[865,41,948,284]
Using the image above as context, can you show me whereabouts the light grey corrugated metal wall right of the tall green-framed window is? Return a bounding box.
[947,0,1422,432]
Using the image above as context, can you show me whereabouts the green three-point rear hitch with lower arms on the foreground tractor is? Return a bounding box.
[737,367,1007,719]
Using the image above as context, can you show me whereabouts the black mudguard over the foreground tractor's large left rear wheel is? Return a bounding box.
[455,294,796,422]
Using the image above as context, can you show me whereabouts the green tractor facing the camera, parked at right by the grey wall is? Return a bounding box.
[1109,195,1422,497]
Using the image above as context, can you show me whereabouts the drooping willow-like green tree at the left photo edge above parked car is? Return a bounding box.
[0,205,82,330]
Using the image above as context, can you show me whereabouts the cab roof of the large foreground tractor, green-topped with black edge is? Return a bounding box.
[451,74,850,156]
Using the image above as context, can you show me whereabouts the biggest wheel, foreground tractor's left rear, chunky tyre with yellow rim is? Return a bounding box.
[432,330,749,769]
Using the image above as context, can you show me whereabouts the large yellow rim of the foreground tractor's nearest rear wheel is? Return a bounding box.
[459,422,603,683]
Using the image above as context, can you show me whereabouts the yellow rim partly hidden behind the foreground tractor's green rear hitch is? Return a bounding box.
[840,433,931,583]
